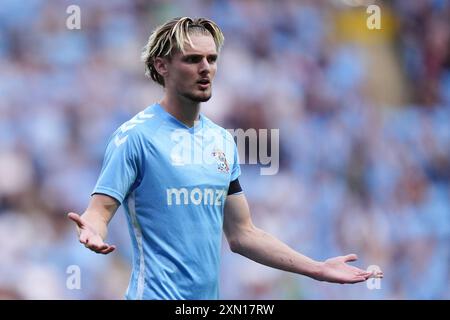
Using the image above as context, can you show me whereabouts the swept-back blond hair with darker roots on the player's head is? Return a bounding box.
[141,17,224,86]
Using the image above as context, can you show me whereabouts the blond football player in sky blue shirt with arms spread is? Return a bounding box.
[68,17,382,299]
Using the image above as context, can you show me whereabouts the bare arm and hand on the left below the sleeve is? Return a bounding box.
[67,194,119,254]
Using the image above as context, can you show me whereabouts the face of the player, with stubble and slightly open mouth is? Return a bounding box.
[165,35,217,102]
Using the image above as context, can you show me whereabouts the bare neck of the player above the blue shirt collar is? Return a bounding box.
[160,95,200,128]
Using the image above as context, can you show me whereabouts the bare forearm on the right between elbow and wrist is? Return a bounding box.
[230,227,322,279]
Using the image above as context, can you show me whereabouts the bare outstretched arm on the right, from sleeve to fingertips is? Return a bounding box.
[224,193,383,283]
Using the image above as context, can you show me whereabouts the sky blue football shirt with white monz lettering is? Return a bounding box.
[93,104,241,299]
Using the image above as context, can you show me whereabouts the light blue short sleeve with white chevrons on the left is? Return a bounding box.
[92,130,140,203]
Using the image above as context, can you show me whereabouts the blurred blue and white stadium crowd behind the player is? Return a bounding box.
[0,0,450,299]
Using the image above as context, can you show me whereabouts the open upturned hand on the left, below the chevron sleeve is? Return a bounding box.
[67,212,116,254]
